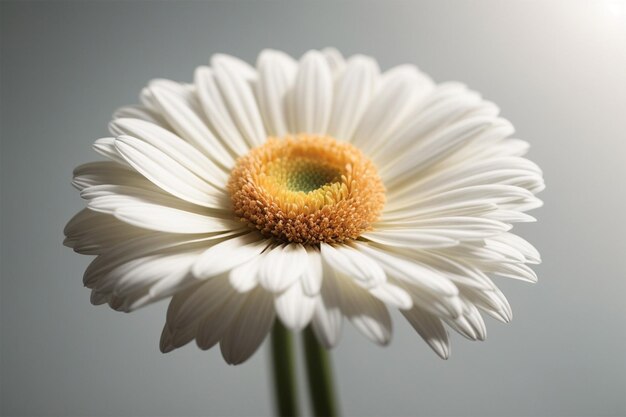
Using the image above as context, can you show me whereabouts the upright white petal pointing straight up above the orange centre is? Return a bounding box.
[292,51,333,134]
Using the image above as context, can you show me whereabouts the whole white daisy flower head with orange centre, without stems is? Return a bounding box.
[65,49,544,363]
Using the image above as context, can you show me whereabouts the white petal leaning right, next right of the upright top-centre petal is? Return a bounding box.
[328,56,380,140]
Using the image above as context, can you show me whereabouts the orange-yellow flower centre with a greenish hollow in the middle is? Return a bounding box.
[228,134,385,244]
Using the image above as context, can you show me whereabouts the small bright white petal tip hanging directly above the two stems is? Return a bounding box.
[274,282,315,331]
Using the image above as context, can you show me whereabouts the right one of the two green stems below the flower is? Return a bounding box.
[303,326,338,417]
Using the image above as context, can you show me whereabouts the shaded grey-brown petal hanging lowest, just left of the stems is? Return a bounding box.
[220,288,274,365]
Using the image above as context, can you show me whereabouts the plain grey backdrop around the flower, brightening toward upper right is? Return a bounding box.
[0,1,626,416]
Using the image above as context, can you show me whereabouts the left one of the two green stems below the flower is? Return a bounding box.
[272,320,300,417]
